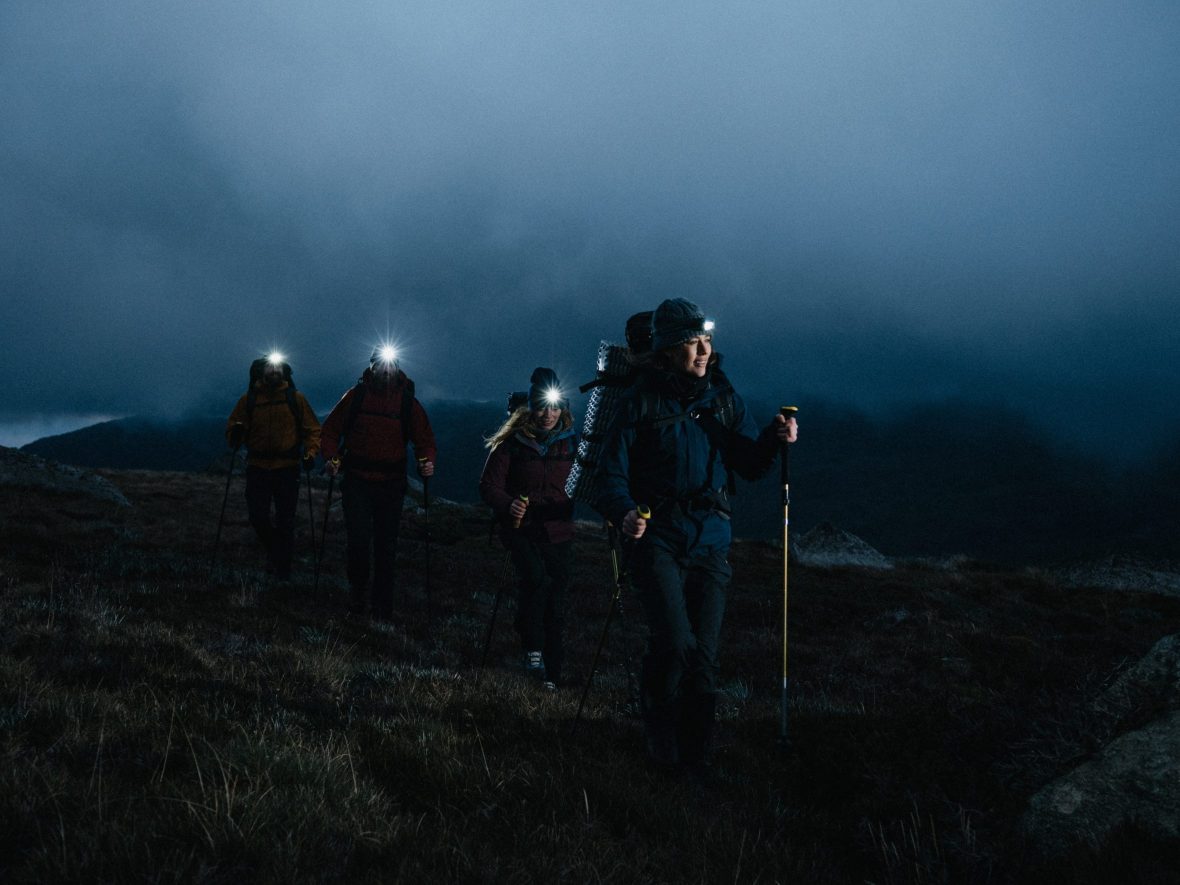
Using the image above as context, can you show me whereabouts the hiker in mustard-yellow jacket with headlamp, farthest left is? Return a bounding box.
[225,354,320,584]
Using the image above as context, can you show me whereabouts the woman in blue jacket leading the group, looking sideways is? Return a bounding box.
[597,299,797,772]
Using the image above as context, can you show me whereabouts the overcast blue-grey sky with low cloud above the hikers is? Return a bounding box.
[0,0,1180,464]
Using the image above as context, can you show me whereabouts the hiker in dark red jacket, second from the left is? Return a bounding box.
[323,347,437,622]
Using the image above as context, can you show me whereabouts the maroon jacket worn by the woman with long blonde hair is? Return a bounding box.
[479,431,578,544]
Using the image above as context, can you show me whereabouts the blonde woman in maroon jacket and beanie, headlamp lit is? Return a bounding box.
[479,368,577,689]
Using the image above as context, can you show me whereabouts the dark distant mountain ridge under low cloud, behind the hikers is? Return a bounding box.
[22,400,1180,563]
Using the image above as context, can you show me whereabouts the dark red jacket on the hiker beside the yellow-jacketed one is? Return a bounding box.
[320,369,438,481]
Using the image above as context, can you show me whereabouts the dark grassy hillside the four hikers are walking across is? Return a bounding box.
[0,471,1180,883]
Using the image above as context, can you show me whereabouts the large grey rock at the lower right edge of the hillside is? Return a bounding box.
[1023,635,1180,854]
